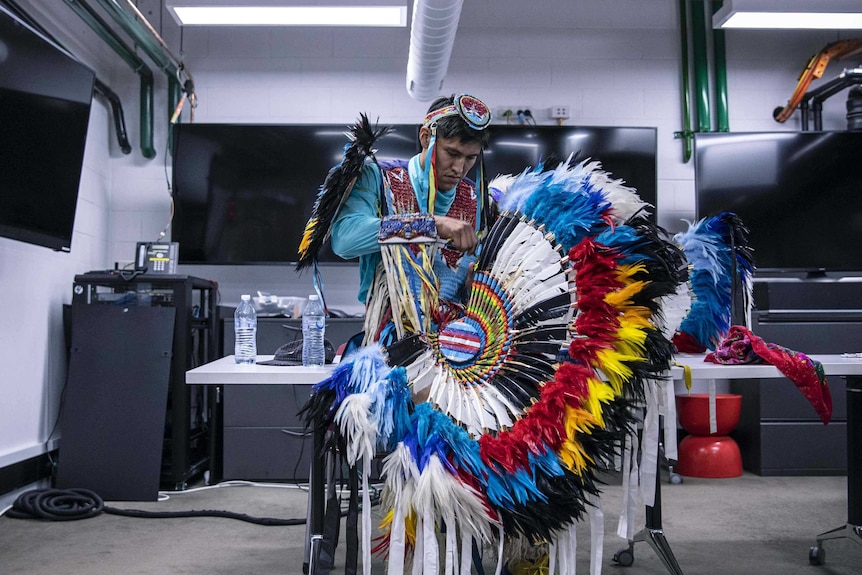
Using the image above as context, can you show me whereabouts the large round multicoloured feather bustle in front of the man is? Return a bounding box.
[305,155,684,574]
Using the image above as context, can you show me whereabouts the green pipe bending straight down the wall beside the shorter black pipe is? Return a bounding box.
[65,0,156,160]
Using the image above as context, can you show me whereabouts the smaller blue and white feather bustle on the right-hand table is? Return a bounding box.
[673,212,754,353]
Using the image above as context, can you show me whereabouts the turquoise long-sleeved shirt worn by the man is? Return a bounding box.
[331,154,476,303]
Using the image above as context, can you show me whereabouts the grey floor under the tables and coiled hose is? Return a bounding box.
[0,473,862,575]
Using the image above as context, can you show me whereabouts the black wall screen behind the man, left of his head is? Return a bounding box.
[171,124,419,264]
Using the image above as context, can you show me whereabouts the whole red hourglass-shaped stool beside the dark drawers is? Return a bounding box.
[676,393,742,478]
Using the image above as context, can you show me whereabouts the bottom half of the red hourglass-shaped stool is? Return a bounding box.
[676,435,742,478]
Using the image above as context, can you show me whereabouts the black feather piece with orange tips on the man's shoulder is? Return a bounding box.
[296,114,392,298]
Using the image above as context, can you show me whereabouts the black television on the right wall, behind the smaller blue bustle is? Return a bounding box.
[694,132,862,275]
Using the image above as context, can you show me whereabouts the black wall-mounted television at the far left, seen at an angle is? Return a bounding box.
[0,6,95,252]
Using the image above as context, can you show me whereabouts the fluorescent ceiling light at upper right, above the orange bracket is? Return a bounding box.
[712,0,862,30]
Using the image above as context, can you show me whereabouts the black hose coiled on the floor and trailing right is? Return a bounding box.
[6,489,305,526]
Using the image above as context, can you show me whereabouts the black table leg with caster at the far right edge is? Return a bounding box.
[808,376,862,565]
